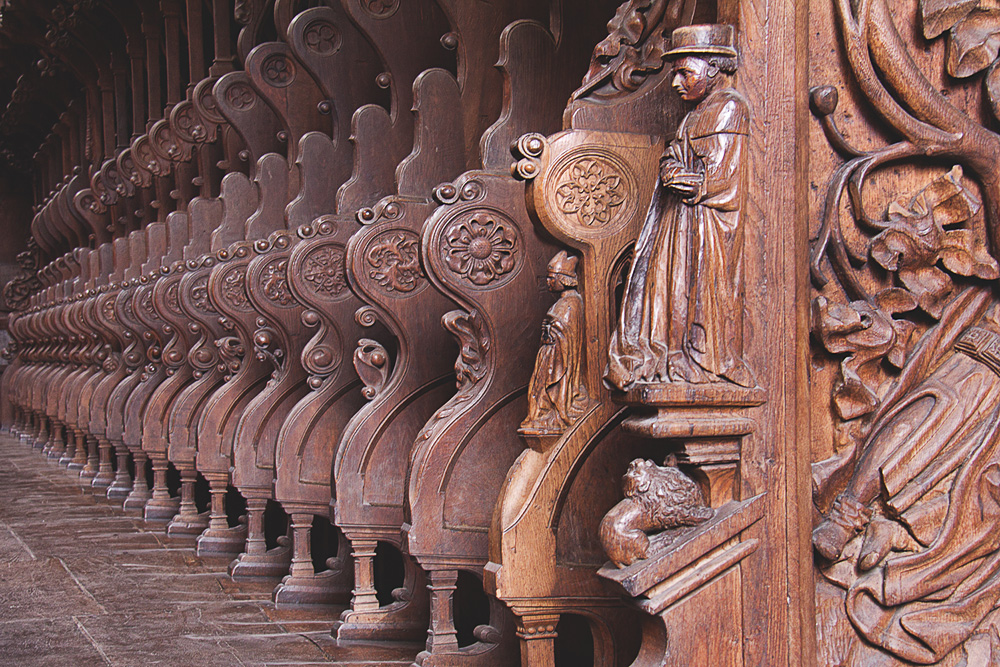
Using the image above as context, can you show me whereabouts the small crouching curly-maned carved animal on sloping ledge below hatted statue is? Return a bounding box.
[600,454,714,567]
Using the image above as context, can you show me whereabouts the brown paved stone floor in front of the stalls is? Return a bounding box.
[0,435,421,667]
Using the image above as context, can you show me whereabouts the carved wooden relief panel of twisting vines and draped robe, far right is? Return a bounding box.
[810,0,1000,665]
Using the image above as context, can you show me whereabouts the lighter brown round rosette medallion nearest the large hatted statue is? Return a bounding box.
[546,146,638,237]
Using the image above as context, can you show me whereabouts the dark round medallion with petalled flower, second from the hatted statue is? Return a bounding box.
[441,209,521,288]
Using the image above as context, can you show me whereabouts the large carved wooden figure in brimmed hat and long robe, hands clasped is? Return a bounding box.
[607,25,755,390]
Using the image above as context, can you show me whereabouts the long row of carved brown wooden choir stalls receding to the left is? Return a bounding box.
[0,0,800,667]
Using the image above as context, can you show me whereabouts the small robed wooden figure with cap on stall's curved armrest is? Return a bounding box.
[520,251,590,435]
